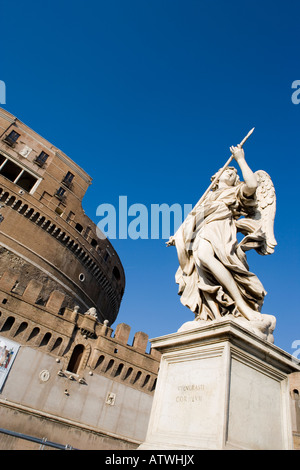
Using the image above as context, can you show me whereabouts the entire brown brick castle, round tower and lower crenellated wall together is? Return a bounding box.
[0,110,160,449]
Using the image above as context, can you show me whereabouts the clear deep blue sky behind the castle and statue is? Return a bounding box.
[0,0,300,353]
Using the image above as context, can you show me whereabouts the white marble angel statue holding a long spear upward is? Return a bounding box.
[167,129,276,342]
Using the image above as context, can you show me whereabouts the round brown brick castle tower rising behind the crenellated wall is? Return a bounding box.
[0,109,125,325]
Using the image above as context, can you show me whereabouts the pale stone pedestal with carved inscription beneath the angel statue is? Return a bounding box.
[139,319,300,450]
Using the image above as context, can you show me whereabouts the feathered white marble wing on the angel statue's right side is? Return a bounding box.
[236,170,277,255]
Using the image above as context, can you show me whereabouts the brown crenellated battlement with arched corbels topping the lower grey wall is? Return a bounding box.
[0,270,160,393]
